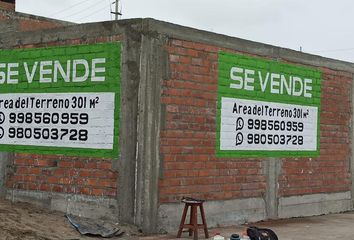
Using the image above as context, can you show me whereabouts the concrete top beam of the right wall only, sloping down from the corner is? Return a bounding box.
[143,18,354,73]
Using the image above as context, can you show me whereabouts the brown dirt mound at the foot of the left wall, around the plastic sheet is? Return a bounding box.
[0,200,139,240]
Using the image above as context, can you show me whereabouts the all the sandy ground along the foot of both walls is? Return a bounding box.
[0,200,354,240]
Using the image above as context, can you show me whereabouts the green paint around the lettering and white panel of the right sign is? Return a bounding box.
[216,51,322,157]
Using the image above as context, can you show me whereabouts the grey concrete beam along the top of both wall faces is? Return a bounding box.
[0,14,354,73]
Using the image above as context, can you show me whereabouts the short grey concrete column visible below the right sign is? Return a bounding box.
[264,158,281,219]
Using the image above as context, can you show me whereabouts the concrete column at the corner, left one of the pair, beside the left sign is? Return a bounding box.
[116,25,141,224]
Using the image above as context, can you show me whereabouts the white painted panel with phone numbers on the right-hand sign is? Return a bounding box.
[220,97,318,151]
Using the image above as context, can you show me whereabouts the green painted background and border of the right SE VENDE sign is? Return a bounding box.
[216,51,322,158]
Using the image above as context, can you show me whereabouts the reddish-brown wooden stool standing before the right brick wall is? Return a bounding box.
[177,198,209,240]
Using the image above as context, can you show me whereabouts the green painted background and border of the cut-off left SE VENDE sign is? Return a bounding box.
[0,42,121,159]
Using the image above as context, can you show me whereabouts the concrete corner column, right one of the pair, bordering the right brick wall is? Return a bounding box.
[136,20,167,233]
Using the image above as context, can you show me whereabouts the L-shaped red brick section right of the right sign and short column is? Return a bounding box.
[279,68,353,196]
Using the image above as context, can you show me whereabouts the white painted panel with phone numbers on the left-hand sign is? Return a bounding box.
[0,92,115,149]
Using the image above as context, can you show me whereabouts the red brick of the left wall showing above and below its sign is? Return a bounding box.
[6,36,122,198]
